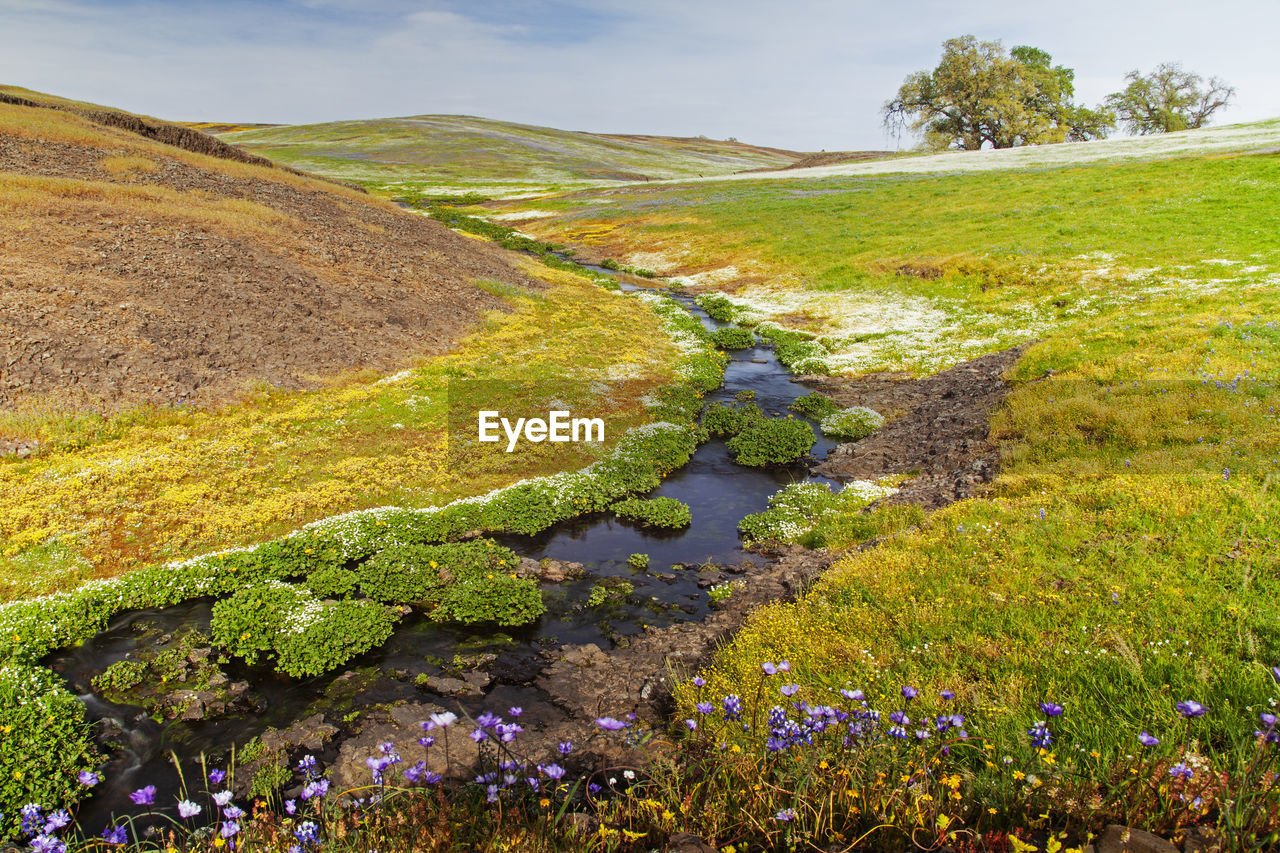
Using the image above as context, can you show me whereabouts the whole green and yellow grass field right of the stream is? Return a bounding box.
[476,128,1280,849]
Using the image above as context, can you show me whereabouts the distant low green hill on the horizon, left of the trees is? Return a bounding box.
[211,115,804,186]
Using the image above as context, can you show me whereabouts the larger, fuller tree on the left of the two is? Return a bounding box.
[883,36,1114,150]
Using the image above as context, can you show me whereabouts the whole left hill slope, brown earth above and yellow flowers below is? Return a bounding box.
[0,88,675,591]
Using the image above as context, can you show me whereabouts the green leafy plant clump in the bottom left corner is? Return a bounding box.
[0,663,99,839]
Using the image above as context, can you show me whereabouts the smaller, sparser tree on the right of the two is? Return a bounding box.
[1107,63,1235,134]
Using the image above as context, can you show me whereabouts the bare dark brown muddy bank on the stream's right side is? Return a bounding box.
[810,345,1030,510]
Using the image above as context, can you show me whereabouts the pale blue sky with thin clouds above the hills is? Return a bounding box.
[0,0,1280,151]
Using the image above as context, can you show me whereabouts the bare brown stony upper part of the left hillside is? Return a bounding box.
[0,91,540,409]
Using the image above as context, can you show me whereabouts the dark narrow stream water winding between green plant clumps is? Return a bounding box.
[45,274,836,834]
